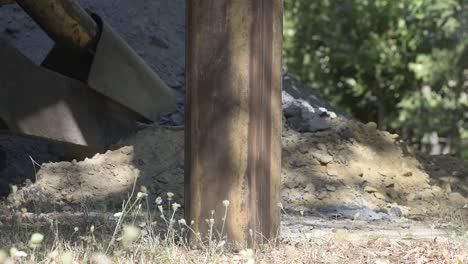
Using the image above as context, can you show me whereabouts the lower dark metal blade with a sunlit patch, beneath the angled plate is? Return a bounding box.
[0,40,137,151]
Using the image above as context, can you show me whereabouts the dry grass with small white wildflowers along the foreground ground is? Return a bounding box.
[0,184,468,264]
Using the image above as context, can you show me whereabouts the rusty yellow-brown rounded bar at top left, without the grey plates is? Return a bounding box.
[16,0,99,50]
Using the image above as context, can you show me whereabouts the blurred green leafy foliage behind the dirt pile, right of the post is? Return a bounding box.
[284,0,468,155]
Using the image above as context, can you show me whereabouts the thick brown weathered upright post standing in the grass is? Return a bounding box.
[185,0,283,246]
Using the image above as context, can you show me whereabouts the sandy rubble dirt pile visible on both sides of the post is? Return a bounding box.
[11,102,468,220]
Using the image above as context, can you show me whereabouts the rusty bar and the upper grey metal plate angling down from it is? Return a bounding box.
[17,0,175,121]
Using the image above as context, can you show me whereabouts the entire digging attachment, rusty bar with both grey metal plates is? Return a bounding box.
[0,0,175,153]
